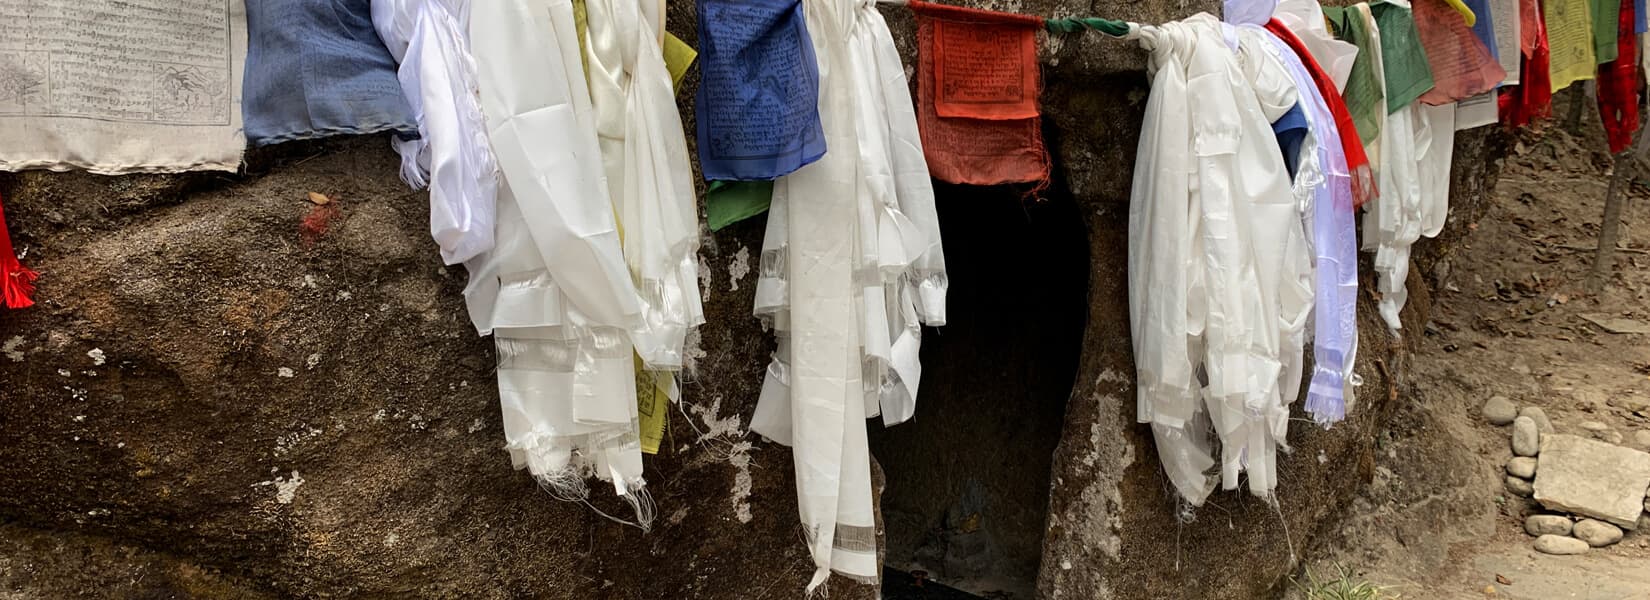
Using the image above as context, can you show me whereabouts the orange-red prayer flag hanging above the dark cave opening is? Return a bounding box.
[909,0,1049,185]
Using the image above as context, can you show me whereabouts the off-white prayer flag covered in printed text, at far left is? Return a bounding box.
[0,0,247,175]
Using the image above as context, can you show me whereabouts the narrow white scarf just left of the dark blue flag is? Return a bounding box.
[586,0,705,371]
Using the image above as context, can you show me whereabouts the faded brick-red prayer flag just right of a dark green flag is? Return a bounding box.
[1405,0,1506,103]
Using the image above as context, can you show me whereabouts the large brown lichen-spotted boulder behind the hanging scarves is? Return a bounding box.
[0,0,1505,598]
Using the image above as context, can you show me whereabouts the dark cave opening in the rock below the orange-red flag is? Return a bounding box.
[870,181,1089,600]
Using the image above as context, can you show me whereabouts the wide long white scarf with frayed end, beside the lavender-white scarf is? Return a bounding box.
[467,0,653,529]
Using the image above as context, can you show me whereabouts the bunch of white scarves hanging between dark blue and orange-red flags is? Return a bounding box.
[751,0,947,592]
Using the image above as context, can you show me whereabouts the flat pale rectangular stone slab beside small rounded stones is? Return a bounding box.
[1535,434,1650,529]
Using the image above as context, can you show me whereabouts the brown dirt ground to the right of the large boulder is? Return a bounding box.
[1307,108,1650,600]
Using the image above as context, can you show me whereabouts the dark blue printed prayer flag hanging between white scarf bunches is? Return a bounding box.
[695,0,825,181]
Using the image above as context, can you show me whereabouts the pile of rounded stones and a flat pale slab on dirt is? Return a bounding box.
[1483,396,1650,554]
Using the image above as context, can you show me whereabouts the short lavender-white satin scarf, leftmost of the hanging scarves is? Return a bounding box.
[373,0,498,264]
